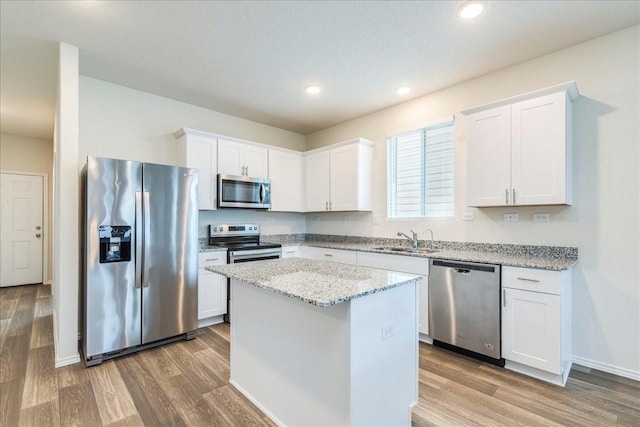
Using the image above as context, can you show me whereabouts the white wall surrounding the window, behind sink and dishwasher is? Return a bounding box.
[307,26,640,378]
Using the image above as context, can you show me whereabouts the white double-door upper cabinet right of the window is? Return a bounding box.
[463,82,578,207]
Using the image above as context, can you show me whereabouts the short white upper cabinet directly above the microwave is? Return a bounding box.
[218,138,269,178]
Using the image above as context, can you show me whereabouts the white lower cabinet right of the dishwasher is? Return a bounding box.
[502,266,571,385]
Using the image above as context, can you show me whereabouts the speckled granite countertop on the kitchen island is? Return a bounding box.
[206,258,421,307]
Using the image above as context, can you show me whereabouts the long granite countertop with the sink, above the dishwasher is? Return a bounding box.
[263,235,578,271]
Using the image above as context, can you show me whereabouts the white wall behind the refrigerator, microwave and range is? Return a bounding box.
[79,76,305,237]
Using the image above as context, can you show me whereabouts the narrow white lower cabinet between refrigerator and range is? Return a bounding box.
[198,251,227,327]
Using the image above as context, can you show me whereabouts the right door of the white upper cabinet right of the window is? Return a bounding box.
[511,92,571,205]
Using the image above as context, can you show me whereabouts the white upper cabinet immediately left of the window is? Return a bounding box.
[305,138,374,212]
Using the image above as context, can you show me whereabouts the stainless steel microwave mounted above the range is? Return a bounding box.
[218,173,271,209]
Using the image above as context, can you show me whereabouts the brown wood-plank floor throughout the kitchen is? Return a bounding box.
[0,285,640,427]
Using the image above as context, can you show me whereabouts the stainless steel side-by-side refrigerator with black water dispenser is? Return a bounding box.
[81,157,199,366]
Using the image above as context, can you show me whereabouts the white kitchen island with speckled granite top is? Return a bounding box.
[208,258,420,426]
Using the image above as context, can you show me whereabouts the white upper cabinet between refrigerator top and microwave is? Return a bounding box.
[174,128,218,210]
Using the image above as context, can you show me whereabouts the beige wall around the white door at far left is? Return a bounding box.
[0,133,53,283]
